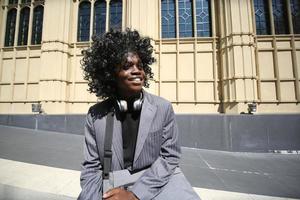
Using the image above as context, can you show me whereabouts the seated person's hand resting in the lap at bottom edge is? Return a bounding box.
[103,188,138,200]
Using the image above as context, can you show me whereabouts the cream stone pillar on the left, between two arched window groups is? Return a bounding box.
[39,0,72,114]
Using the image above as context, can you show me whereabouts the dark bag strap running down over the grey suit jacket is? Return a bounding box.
[102,112,114,179]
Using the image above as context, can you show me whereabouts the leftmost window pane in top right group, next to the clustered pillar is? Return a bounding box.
[254,0,271,35]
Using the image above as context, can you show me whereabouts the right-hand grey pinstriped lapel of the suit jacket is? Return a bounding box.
[133,92,157,164]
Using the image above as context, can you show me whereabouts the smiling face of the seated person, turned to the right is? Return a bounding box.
[117,52,145,98]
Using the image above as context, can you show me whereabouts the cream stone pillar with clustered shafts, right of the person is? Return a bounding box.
[219,0,257,113]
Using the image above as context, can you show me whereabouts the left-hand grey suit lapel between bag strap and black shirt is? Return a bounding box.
[112,115,124,168]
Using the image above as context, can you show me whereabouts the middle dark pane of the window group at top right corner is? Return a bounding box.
[272,0,289,34]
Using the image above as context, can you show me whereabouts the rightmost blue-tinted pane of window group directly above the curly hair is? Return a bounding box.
[109,0,122,30]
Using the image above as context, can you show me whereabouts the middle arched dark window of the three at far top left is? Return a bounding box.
[18,7,30,45]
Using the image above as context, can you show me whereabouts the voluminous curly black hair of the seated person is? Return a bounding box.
[81,28,155,98]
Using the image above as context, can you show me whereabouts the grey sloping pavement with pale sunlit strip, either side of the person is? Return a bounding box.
[0,125,300,200]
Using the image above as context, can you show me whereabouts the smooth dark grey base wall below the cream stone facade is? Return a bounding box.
[0,114,300,152]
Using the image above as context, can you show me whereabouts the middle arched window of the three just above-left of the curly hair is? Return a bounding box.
[93,0,106,34]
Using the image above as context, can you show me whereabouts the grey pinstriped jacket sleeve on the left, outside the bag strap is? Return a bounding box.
[78,113,102,200]
